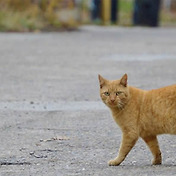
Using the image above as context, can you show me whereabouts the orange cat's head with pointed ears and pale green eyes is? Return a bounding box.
[98,74,129,109]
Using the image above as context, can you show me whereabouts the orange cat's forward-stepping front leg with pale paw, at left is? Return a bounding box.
[108,134,138,166]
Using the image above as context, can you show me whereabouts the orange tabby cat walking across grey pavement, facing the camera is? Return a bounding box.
[98,74,176,166]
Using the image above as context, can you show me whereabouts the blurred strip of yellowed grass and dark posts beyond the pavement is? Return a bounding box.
[0,0,176,32]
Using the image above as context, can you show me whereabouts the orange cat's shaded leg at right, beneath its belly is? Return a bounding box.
[143,136,162,165]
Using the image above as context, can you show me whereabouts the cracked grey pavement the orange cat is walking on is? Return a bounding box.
[0,26,176,176]
